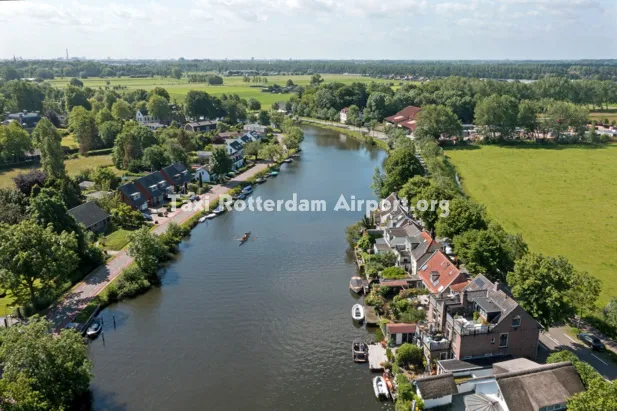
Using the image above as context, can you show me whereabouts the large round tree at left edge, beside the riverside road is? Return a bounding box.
[0,220,79,304]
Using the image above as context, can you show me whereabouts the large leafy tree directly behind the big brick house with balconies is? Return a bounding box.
[507,253,575,329]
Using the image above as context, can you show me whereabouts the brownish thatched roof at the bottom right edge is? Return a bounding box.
[495,362,585,411]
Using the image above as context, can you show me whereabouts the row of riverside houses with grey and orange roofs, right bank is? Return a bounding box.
[372,194,540,370]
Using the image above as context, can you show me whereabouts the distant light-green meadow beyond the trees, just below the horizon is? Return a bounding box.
[48,74,384,108]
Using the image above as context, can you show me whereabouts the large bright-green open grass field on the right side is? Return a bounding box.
[446,145,617,307]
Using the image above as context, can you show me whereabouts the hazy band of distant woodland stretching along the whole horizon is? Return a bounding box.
[7,58,617,79]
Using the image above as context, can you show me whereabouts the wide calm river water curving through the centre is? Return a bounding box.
[90,127,386,410]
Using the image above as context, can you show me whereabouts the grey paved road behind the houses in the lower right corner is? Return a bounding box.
[538,327,617,380]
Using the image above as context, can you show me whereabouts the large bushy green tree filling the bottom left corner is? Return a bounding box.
[0,319,92,411]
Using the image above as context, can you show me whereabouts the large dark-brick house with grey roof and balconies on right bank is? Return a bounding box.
[419,276,540,366]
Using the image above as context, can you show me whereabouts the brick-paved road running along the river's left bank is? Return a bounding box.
[47,164,268,329]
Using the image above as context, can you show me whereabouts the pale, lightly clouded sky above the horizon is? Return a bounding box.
[0,0,617,60]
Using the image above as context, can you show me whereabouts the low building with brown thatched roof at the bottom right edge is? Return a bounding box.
[414,359,585,411]
